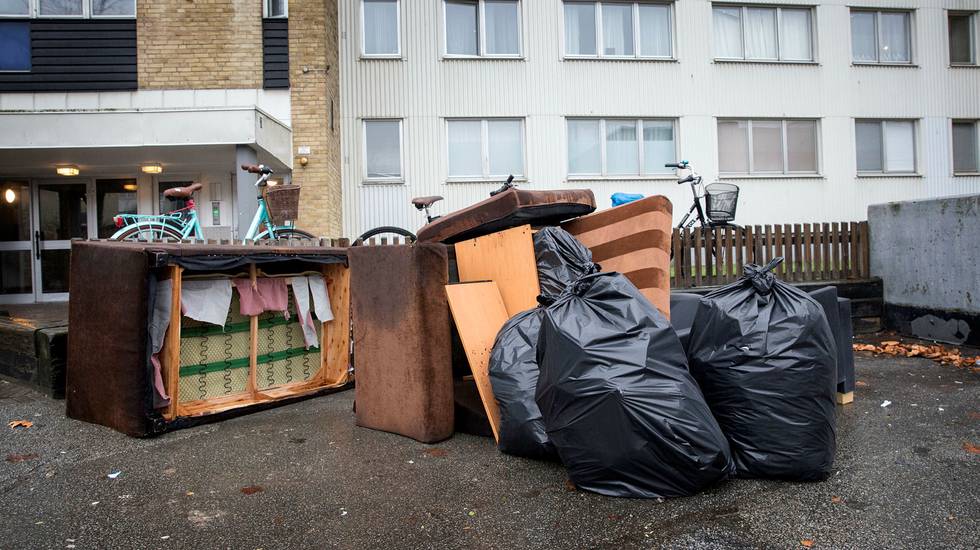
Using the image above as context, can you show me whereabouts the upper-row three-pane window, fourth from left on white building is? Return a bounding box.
[712,4,813,61]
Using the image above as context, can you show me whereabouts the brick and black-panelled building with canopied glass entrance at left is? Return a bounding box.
[0,0,340,303]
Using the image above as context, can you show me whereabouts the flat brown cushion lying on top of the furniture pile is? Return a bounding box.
[418,188,595,244]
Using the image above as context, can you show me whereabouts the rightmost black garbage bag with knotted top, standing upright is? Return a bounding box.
[688,258,837,481]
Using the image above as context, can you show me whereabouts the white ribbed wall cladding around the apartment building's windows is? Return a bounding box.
[339,0,980,235]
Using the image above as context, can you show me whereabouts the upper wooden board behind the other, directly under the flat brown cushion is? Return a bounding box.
[455,225,540,320]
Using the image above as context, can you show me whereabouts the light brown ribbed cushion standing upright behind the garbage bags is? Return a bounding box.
[562,195,673,319]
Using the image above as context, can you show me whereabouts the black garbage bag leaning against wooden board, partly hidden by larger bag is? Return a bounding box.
[489,308,557,459]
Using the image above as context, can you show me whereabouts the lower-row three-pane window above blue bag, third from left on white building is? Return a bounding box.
[568,118,677,177]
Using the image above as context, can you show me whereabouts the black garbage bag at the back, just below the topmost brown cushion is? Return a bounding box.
[534,227,599,300]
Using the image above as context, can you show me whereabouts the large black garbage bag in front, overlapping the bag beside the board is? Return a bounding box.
[537,273,733,498]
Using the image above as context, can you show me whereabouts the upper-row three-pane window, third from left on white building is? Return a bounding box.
[565,0,674,59]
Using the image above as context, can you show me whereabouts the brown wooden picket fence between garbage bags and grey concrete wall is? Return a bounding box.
[670,222,870,288]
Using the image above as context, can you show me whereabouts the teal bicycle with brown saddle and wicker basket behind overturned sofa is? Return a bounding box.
[110,164,316,242]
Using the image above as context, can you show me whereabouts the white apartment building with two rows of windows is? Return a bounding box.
[339,0,980,235]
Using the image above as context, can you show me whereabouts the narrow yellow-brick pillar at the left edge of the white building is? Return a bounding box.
[289,0,342,237]
